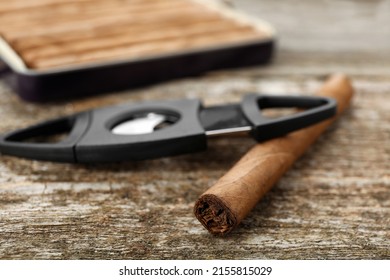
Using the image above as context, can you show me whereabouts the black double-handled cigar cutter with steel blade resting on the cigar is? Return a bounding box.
[0,94,337,163]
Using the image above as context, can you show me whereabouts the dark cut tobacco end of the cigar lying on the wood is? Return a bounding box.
[194,194,238,236]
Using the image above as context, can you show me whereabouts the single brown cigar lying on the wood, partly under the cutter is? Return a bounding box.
[194,74,353,236]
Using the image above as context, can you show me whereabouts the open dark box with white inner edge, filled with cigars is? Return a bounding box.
[0,0,275,101]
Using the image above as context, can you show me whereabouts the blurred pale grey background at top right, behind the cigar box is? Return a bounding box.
[233,0,390,53]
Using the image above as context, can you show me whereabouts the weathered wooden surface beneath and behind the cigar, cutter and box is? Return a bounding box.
[0,0,390,259]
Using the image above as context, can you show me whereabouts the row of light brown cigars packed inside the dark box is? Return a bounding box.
[0,0,269,69]
